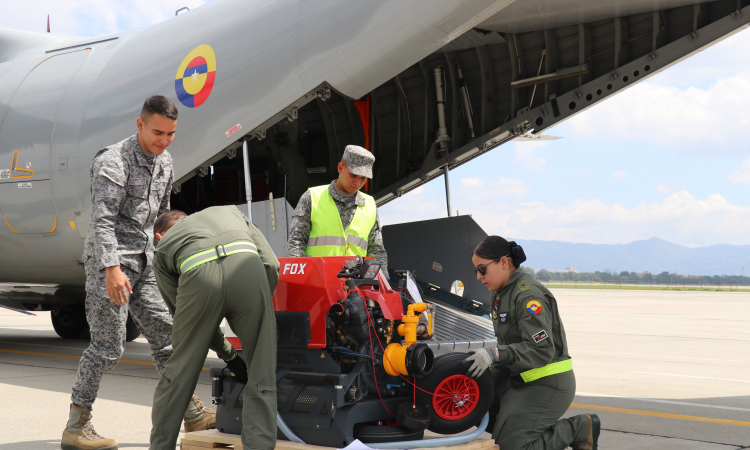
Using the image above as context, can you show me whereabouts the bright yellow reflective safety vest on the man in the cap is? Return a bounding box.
[305,184,378,256]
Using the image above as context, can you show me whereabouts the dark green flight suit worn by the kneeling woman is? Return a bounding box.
[488,269,588,450]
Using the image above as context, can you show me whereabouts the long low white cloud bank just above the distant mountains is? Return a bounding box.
[473,190,750,245]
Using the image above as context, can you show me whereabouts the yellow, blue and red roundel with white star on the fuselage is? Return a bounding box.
[174,44,216,108]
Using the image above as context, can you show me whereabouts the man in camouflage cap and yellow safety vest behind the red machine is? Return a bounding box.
[287,145,388,277]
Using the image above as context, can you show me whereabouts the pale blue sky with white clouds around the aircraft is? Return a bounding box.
[0,0,750,247]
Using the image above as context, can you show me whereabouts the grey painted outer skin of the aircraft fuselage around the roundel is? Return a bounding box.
[0,0,510,285]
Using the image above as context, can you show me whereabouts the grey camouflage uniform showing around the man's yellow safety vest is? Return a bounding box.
[287,181,388,274]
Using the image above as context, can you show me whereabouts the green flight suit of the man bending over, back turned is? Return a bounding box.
[151,206,279,450]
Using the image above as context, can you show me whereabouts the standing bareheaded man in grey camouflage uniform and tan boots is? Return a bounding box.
[62,96,223,450]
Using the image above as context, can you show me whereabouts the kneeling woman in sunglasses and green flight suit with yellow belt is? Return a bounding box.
[465,236,601,450]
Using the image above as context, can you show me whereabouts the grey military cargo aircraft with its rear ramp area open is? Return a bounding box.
[0,0,750,336]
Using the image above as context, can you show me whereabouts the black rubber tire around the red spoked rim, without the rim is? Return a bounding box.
[417,353,495,434]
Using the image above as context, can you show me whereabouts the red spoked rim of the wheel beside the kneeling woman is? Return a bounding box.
[432,375,479,420]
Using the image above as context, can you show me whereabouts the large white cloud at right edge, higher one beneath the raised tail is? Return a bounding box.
[564,71,750,155]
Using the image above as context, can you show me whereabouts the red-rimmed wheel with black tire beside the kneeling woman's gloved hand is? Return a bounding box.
[417,353,495,434]
